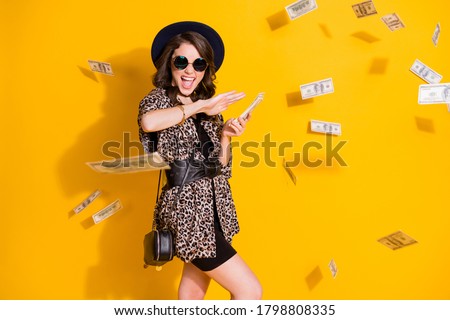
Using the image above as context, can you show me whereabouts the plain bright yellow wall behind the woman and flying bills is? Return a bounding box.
[0,0,450,299]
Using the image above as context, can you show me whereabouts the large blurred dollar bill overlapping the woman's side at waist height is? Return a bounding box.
[86,152,170,173]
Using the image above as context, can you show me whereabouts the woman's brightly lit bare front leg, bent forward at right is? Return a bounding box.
[205,254,262,300]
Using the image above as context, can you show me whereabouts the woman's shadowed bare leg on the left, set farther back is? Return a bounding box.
[178,263,211,300]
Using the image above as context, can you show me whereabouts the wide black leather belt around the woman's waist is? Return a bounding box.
[166,157,222,188]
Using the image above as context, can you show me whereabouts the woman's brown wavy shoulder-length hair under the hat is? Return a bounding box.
[153,31,216,105]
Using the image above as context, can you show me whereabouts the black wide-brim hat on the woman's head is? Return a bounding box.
[151,21,225,71]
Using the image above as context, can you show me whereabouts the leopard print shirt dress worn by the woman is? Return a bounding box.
[138,88,239,262]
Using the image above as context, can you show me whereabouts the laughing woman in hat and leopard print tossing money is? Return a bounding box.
[138,21,261,299]
